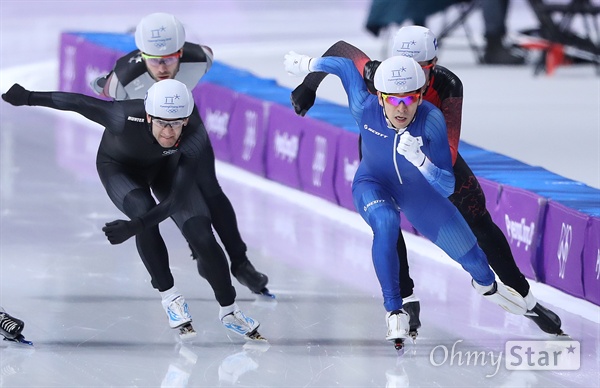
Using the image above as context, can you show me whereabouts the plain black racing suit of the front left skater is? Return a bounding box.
[29,92,236,306]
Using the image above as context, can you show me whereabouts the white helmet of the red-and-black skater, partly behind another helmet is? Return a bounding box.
[391,26,437,62]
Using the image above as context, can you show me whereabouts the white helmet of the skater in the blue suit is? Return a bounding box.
[373,55,425,94]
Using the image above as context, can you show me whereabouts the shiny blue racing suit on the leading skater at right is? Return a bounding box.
[311,57,495,311]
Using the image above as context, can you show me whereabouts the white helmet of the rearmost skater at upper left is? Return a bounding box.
[135,13,185,56]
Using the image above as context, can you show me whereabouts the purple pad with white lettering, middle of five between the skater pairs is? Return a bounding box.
[265,104,306,189]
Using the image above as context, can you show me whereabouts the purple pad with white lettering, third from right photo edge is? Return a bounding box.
[492,186,546,279]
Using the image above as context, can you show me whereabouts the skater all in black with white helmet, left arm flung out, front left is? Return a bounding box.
[2,79,259,338]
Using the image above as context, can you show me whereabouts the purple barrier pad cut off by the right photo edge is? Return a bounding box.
[583,217,600,305]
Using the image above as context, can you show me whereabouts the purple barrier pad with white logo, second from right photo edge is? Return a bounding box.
[542,201,589,298]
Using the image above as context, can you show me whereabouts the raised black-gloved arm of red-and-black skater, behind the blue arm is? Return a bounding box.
[290,40,369,116]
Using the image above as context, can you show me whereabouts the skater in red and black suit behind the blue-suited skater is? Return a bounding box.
[291,26,563,336]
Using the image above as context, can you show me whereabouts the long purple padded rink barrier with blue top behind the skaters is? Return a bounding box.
[59,32,600,305]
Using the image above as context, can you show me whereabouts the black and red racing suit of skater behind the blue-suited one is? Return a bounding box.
[291,41,529,298]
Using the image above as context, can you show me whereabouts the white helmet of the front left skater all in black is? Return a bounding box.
[144,79,194,119]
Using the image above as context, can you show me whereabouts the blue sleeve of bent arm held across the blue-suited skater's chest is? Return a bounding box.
[419,109,455,198]
